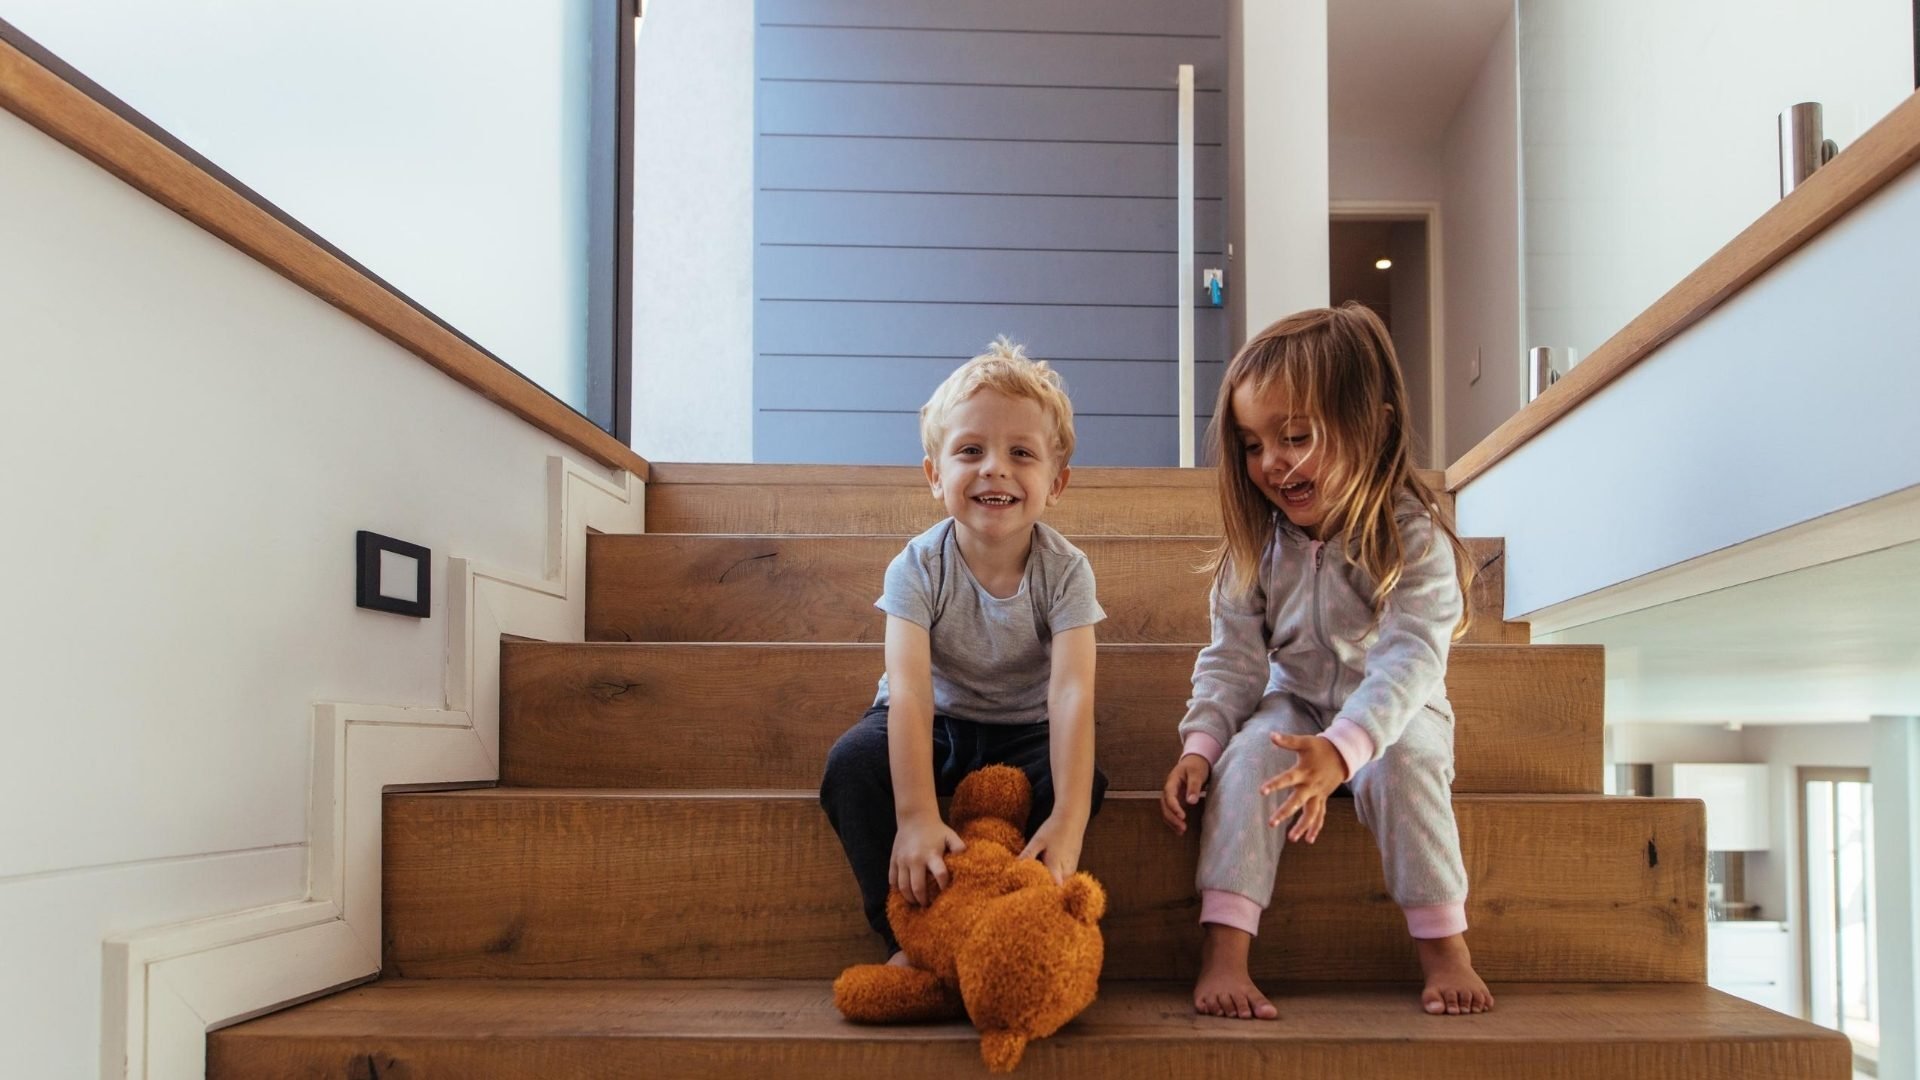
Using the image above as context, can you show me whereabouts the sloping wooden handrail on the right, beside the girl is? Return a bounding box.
[1446,92,1920,492]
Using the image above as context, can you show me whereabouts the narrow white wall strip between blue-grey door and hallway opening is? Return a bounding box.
[1227,0,1329,332]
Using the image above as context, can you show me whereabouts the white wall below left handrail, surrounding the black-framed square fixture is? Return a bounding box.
[0,98,622,1078]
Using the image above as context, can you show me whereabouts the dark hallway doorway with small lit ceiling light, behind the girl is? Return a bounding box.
[1327,204,1446,469]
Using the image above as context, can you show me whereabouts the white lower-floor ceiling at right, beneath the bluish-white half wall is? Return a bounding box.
[1538,542,1920,724]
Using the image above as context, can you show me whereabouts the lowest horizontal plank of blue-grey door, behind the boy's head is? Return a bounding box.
[753,411,1206,466]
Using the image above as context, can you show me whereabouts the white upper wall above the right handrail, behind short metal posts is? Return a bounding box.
[1519,0,1914,368]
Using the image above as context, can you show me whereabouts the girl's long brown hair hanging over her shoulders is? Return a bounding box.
[1206,302,1473,638]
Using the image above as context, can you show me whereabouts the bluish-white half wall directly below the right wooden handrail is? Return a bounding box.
[1448,157,1920,619]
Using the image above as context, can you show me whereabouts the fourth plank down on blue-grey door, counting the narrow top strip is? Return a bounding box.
[756,135,1227,198]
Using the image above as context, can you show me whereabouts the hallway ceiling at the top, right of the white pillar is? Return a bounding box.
[1327,0,1513,146]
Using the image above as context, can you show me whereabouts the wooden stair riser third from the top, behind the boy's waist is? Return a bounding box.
[501,642,1603,794]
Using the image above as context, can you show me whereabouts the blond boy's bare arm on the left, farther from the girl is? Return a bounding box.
[887,615,966,903]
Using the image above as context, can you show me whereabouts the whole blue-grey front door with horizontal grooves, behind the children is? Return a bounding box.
[755,0,1231,465]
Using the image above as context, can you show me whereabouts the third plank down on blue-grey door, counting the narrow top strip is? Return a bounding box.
[758,83,1227,144]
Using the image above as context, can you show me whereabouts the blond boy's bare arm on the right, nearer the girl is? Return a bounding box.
[1021,626,1094,882]
